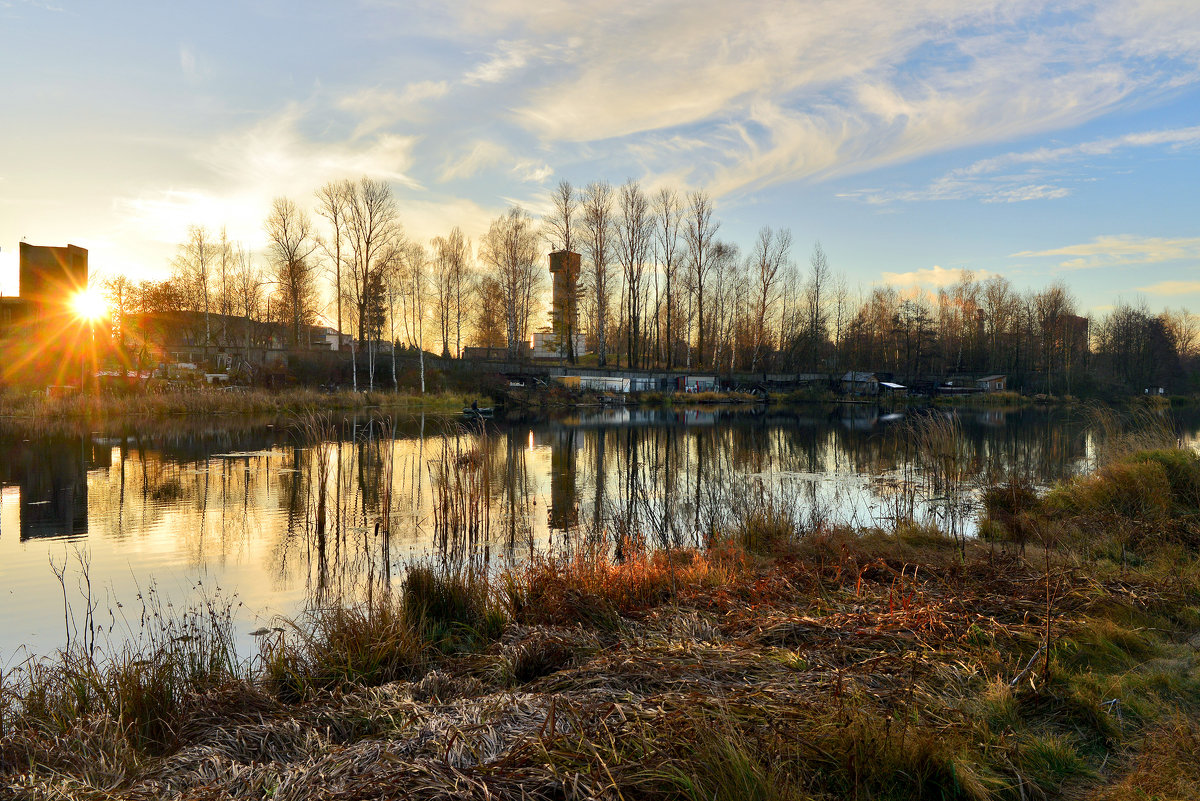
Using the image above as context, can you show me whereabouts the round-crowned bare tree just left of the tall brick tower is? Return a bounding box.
[479,206,542,359]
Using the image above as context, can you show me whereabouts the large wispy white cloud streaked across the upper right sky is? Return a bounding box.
[415,0,1200,203]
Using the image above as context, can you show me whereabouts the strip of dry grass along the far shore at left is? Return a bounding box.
[0,389,478,422]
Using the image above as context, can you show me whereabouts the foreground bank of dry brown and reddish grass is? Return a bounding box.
[7,439,1200,800]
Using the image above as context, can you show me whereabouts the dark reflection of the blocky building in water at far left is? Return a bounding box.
[0,439,92,541]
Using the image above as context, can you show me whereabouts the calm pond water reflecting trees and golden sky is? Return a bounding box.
[0,406,1198,667]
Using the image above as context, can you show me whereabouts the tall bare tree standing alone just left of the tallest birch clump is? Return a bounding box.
[266,198,317,347]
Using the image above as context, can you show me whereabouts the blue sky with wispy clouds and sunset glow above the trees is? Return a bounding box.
[0,0,1200,312]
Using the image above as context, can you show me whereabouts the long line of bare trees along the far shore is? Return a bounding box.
[108,177,1200,393]
